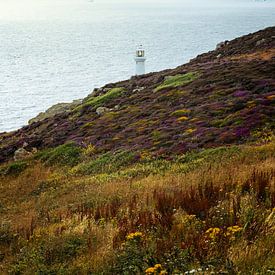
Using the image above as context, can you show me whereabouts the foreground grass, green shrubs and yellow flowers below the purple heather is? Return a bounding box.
[0,141,275,274]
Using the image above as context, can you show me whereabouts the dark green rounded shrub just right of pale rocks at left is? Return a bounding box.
[36,142,82,166]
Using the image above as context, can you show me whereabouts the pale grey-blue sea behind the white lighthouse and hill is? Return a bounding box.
[0,0,275,132]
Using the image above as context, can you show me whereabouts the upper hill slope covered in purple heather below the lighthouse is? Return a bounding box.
[0,27,275,162]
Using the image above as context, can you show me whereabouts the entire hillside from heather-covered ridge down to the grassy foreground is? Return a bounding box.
[0,27,275,274]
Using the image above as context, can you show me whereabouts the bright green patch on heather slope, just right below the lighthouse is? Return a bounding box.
[154,72,199,92]
